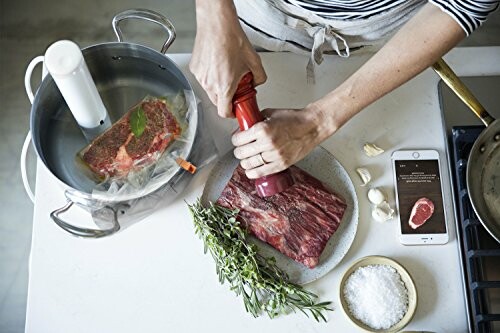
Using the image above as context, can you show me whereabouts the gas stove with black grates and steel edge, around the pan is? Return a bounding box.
[439,77,500,333]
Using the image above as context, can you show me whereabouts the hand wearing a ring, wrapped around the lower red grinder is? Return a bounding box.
[232,107,328,179]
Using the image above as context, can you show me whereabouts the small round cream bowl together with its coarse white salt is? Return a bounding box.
[340,256,417,333]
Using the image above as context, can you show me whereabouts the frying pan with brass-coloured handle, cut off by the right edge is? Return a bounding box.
[432,59,500,243]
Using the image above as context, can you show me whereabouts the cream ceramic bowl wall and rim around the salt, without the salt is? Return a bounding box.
[339,256,417,333]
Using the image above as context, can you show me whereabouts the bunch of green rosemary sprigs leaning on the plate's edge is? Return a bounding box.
[188,200,332,322]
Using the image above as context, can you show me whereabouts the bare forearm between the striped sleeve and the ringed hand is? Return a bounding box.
[309,4,465,136]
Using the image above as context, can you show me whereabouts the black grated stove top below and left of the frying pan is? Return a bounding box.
[450,126,500,333]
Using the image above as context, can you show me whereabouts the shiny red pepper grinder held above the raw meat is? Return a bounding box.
[233,72,294,197]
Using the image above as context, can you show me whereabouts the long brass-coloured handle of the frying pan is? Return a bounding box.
[432,58,495,126]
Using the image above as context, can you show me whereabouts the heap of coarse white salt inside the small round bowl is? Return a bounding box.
[343,265,408,329]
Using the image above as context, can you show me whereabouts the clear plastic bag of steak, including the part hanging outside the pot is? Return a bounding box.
[70,91,218,230]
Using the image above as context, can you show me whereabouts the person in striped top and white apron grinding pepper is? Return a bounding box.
[189,0,499,179]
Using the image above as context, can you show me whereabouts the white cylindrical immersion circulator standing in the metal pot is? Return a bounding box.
[45,40,111,141]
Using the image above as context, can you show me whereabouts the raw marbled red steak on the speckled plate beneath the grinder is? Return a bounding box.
[217,166,347,268]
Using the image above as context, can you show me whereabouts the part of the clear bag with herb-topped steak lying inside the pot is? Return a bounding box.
[77,92,202,201]
